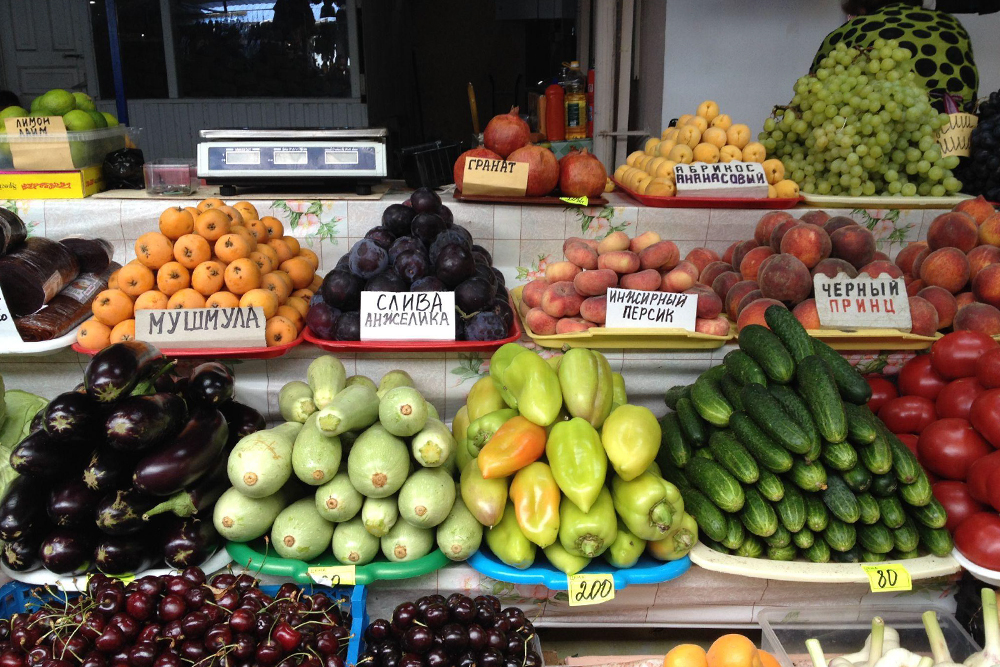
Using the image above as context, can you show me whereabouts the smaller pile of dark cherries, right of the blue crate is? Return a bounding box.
[358,593,542,667]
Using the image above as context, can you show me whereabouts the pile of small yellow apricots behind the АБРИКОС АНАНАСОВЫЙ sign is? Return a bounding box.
[615,100,799,198]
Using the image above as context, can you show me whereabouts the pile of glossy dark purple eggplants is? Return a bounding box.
[0,341,265,575]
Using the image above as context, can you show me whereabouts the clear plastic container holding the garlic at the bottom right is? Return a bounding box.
[757,600,979,667]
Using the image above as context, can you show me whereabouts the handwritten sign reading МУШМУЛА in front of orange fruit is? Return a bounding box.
[135,306,266,349]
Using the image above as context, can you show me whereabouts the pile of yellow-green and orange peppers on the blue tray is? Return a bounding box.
[453,343,698,574]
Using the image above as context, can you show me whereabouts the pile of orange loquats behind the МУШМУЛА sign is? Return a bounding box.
[77,198,320,350]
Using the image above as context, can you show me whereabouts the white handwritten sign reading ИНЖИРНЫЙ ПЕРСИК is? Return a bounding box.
[604,287,698,331]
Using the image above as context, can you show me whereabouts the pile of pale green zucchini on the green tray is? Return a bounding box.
[214,355,482,565]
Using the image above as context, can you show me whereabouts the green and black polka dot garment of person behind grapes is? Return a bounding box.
[810,4,979,111]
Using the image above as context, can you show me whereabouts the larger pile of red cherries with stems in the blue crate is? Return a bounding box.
[0,567,350,667]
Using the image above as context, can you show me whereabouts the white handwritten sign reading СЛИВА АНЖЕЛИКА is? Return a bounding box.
[361,292,455,340]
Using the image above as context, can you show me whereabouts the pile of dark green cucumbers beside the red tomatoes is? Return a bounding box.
[657,306,953,563]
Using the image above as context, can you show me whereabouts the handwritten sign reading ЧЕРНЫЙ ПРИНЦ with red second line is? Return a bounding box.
[813,273,913,331]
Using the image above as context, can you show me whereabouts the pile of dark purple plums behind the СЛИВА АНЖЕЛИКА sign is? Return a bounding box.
[306,188,514,341]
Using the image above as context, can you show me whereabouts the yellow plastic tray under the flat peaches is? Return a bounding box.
[510,286,736,350]
